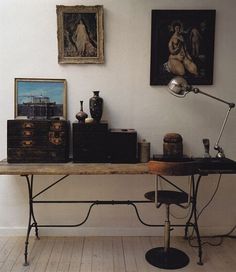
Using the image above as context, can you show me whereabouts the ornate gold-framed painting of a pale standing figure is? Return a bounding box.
[57,5,104,63]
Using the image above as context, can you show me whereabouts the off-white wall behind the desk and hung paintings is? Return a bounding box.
[0,0,236,235]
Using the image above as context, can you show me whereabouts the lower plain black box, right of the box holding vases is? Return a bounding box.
[109,129,137,163]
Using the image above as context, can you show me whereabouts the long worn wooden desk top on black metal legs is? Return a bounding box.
[0,159,236,176]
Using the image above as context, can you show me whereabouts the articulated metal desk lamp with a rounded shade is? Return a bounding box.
[168,76,235,158]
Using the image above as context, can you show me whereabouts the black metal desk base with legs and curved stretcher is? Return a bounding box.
[22,175,202,265]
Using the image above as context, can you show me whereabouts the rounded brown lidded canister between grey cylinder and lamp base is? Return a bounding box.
[163,133,183,157]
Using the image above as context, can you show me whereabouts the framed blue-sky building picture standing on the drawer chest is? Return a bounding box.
[14,78,67,120]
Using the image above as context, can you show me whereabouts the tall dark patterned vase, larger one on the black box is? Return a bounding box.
[89,91,103,123]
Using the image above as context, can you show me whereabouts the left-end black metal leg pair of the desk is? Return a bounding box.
[24,175,39,266]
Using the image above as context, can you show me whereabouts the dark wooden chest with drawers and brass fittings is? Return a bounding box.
[7,119,70,163]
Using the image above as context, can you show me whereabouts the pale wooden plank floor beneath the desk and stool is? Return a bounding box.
[0,237,236,272]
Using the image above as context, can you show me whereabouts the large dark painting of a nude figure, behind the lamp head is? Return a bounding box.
[150,10,216,85]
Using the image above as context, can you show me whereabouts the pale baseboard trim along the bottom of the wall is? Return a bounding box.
[0,227,230,236]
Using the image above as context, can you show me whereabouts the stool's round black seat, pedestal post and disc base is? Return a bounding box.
[145,176,191,269]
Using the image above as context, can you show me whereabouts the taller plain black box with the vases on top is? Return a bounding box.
[72,121,108,162]
